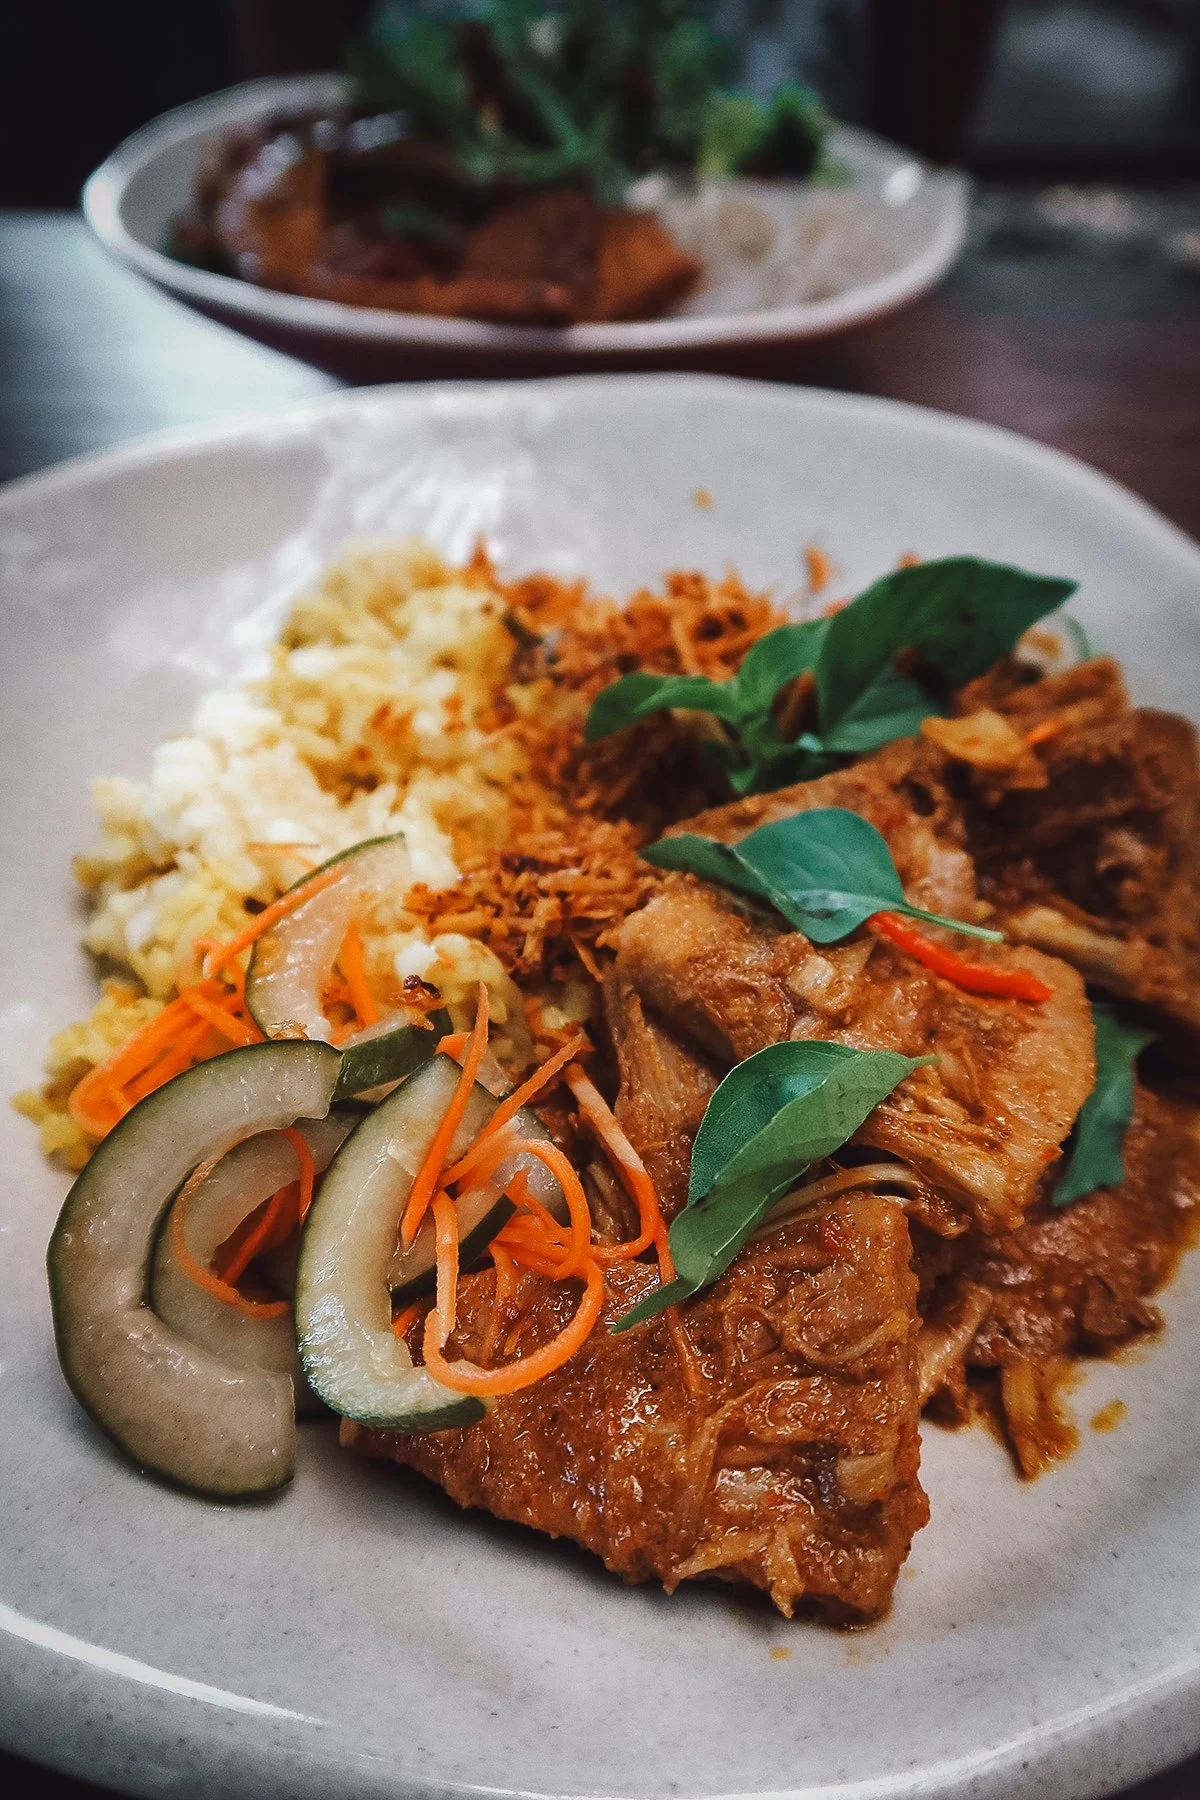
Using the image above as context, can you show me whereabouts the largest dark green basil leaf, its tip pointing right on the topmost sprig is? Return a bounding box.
[817,556,1076,742]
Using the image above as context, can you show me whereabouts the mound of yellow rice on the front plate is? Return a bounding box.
[14,542,543,1166]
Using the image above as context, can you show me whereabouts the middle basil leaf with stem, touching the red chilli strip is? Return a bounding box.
[642,806,1002,943]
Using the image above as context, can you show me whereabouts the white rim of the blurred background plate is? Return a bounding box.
[81,74,972,356]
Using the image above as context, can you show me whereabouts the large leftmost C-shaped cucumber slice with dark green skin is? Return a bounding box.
[47,1042,340,1498]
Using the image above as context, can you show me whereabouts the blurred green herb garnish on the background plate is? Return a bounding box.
[347,0,829,205]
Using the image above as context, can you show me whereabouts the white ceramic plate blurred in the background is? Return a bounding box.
[83,76,968,358]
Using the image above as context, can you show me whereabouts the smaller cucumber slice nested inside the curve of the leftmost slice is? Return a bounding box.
[148,1112,358,1413]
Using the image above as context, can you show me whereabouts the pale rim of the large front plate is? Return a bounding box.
[0,374,1200,1800]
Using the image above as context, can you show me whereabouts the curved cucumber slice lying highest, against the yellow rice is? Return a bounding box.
[246,837,413,1051]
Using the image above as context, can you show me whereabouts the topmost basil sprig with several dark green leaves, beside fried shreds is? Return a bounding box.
[585,556,1076,794]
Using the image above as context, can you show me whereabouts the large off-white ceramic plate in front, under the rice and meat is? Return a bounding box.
[0,376,1200,1800]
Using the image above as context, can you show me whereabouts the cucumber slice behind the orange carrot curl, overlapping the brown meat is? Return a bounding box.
[295,1057,563,1431]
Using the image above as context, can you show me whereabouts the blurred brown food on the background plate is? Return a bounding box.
[173,115,700,324]
